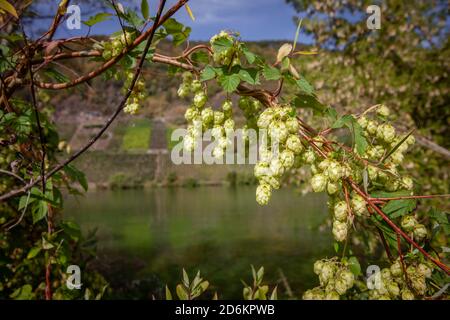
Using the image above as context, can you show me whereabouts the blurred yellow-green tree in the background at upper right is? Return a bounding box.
[286,0,450,199]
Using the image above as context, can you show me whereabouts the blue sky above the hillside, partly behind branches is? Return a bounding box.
[39,0,311,43]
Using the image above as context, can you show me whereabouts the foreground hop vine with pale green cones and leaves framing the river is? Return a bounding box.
[0,0,449,299]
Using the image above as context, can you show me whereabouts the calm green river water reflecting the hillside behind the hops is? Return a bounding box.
[65,187,333,298]
